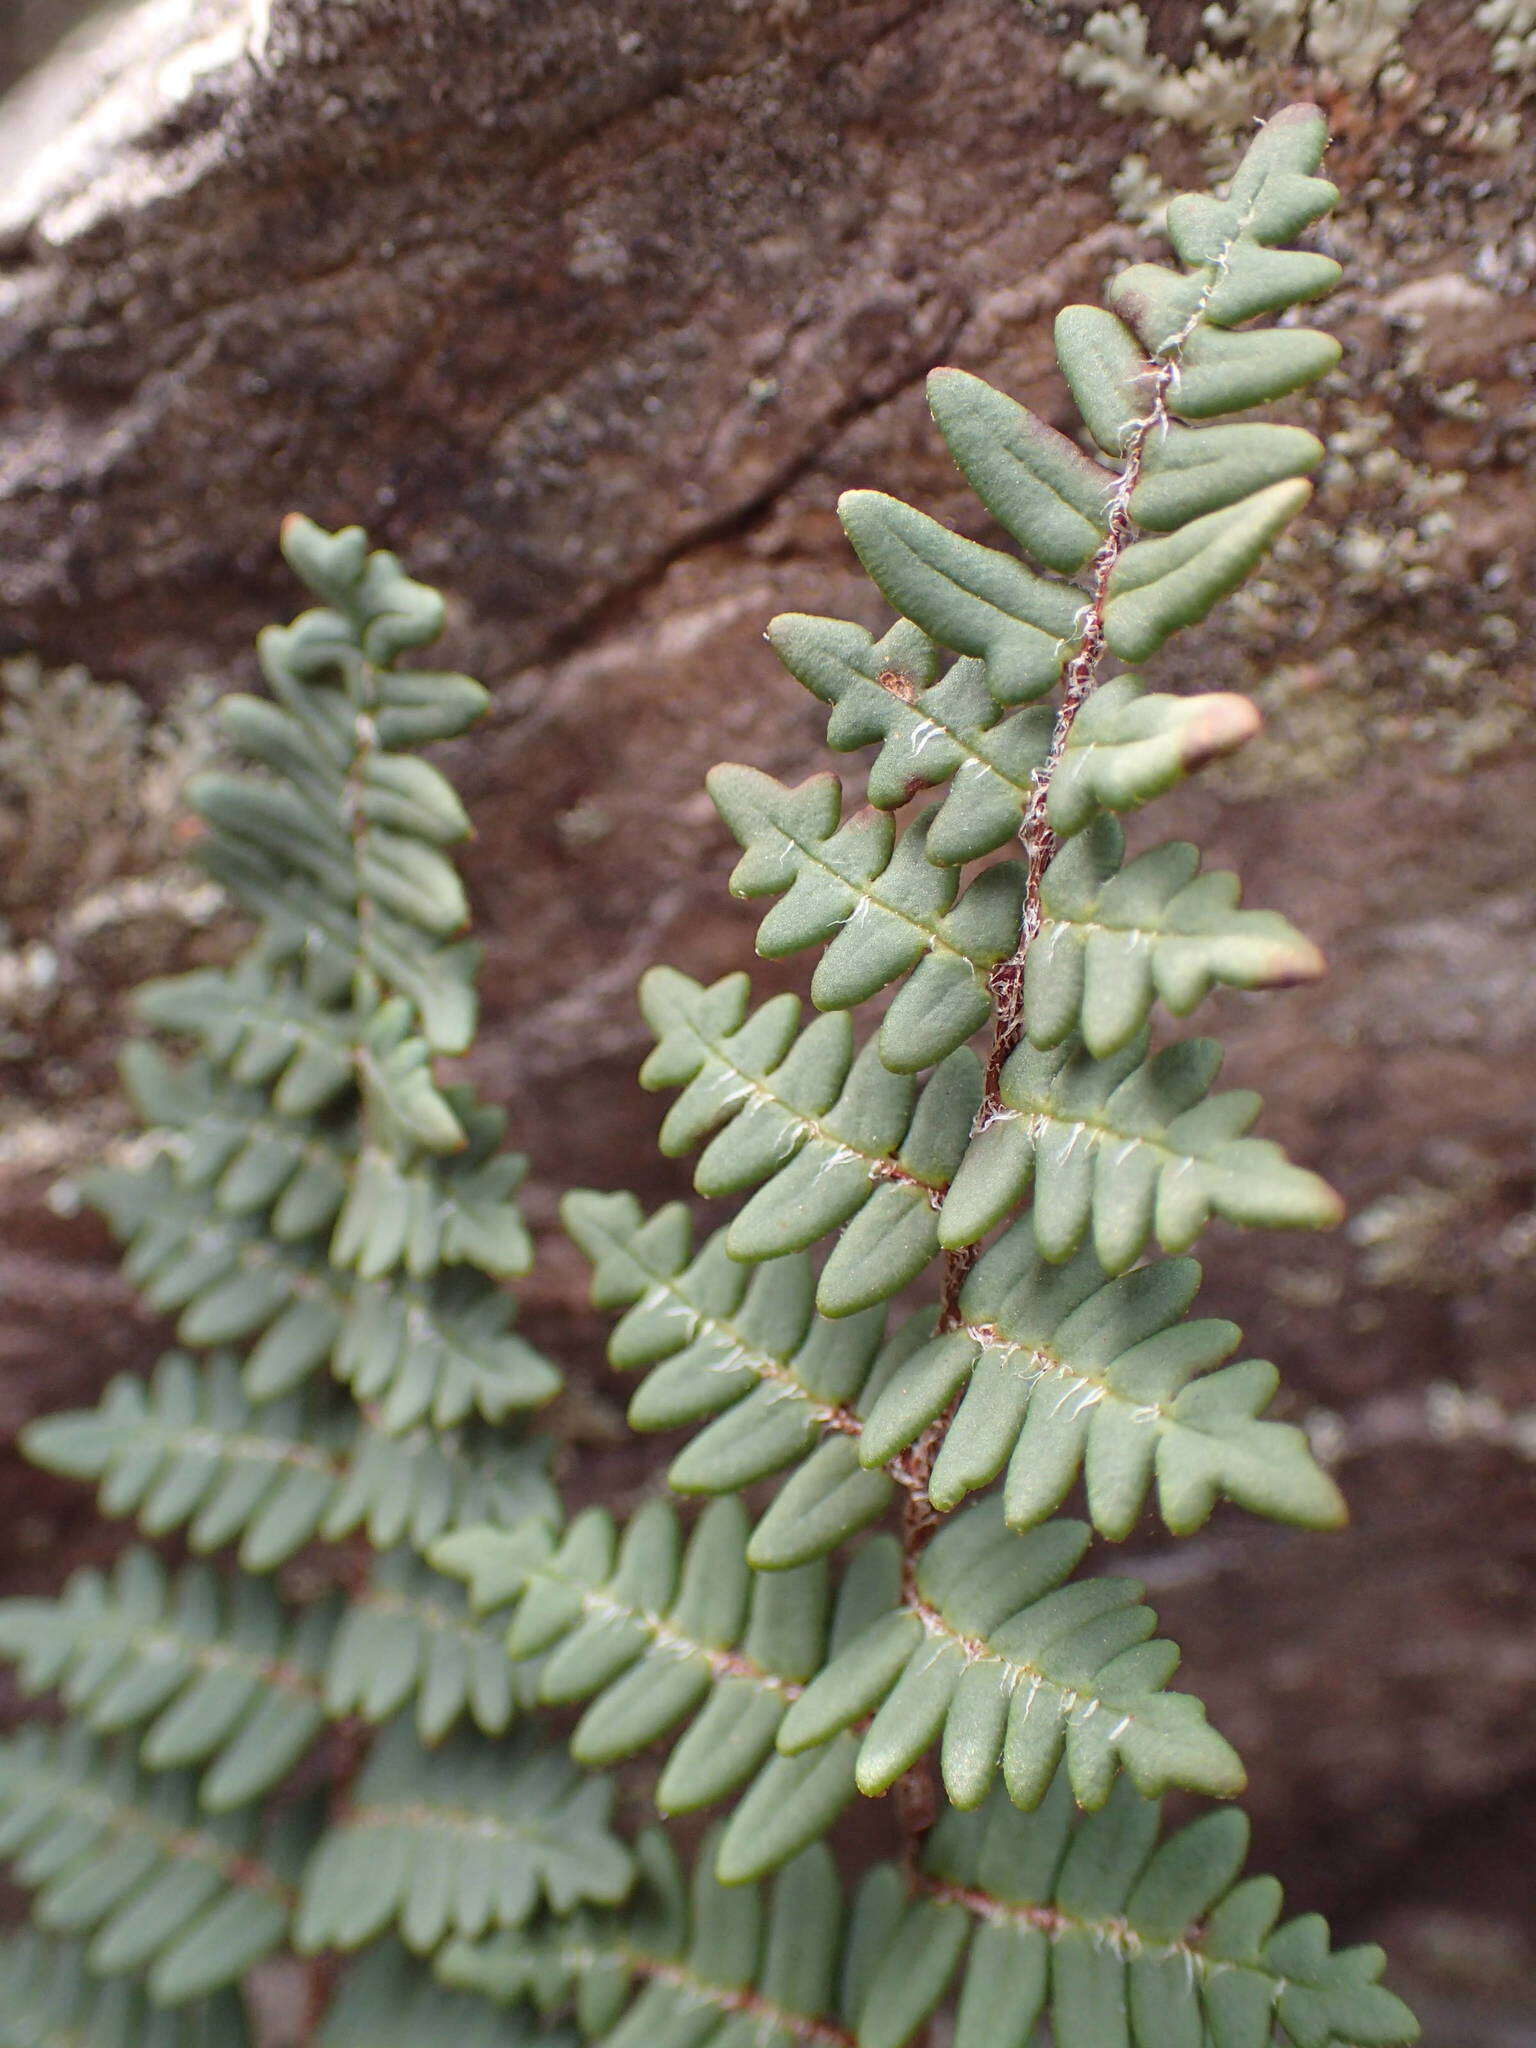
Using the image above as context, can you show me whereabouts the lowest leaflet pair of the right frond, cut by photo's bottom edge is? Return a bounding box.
[440,1780,1417,2048]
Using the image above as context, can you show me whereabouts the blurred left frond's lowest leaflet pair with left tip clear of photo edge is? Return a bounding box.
[23,1352,557,1571]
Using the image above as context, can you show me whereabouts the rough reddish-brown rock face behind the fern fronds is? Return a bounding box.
[0,0,1536,2042]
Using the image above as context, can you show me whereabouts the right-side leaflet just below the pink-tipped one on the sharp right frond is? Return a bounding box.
[1024,806,1323,1059]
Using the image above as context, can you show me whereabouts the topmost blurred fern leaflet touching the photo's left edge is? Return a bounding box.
[0,1550,336,1812]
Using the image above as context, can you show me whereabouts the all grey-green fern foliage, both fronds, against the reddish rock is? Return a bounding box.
[0,109,1415,2048]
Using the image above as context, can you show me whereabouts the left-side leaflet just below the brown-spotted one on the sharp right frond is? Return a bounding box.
[709,770,1024,1073]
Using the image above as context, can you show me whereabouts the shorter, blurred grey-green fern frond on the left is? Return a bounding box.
[0,520,633,2048]
